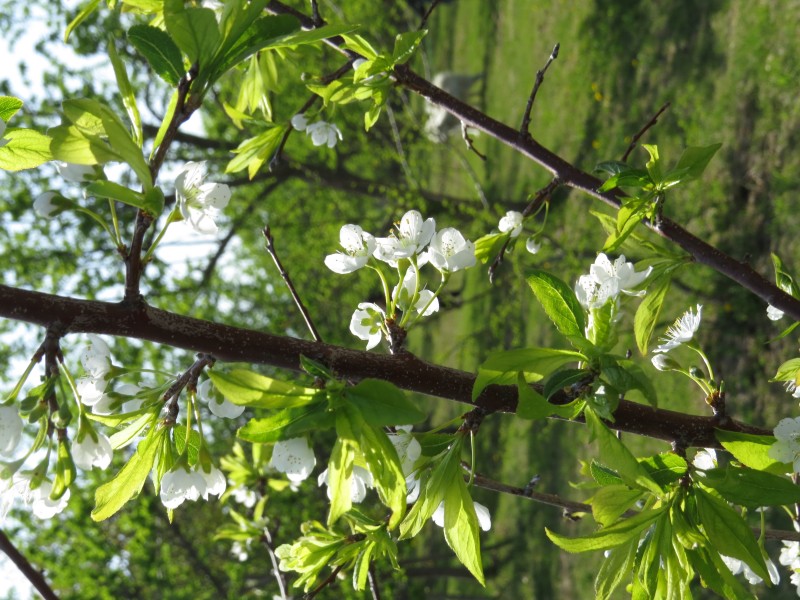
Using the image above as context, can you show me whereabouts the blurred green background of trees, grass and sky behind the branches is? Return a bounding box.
[0,0,800,598]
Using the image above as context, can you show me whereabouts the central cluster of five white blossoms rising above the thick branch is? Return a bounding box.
[325,210,476,350]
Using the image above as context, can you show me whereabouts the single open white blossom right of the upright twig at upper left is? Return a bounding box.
[175,162,231,234]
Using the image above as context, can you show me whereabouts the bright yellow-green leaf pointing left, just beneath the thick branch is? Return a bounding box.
[208,369,320,409]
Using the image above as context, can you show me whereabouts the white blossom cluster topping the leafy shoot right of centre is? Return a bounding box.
[575,253,653,309]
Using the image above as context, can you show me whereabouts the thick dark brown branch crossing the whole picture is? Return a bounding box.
[0,285,771,448]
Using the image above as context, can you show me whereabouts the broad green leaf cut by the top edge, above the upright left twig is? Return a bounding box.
[164,0,219,66]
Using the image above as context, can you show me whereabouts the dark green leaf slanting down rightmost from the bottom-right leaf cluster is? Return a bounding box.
[695,488,769,581]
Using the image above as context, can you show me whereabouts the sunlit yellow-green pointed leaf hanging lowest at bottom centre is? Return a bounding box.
[444,477,486,586]
